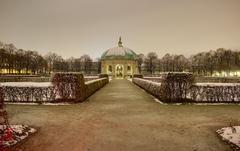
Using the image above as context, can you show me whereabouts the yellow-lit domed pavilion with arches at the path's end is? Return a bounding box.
[101,37,138,78]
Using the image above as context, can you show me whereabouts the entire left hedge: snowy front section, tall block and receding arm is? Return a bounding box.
[2,73,108,103]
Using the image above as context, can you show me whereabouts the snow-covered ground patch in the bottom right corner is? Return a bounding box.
[216,126,240,149]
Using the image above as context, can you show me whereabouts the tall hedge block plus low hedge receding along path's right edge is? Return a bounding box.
[133,73,194,102]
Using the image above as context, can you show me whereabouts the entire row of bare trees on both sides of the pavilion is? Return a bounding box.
[0,42,240,76]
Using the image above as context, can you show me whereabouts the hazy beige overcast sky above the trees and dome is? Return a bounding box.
[0,0,240,58]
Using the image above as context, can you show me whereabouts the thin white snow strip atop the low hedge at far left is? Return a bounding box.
[0,82,52,87]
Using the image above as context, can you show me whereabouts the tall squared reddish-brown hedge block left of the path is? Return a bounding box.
[51,72,85,101]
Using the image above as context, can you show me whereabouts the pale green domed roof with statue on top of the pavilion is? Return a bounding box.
[101,37,137,60]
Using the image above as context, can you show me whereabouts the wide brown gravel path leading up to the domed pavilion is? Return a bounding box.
[7,80,240,151]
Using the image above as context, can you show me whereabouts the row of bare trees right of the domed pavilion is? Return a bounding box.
[138,48,240,76]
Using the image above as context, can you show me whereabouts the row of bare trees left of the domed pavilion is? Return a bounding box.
[0,43,101,75]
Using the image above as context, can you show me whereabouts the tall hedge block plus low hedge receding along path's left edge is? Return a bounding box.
[52,72,109,102]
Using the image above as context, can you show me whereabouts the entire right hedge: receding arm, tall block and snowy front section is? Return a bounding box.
[132,73,240,103]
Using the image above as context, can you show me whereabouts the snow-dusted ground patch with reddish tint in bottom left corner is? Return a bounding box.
[0,125,36,147]
